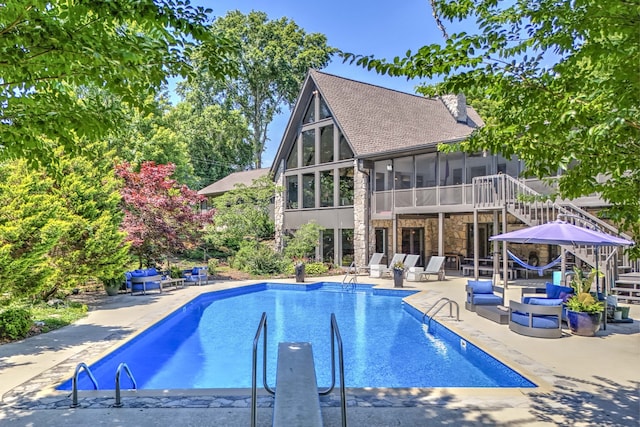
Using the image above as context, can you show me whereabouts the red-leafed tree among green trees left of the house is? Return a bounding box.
[117,162,213,267]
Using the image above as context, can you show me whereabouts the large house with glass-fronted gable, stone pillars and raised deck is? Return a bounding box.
[271,70,624,280]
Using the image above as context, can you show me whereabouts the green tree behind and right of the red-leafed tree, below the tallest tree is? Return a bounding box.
[165,102,253,188]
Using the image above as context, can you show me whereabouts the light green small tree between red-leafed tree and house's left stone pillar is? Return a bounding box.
[205,177,276,251]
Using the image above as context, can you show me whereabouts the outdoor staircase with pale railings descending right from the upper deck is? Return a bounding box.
[473,174,637,290]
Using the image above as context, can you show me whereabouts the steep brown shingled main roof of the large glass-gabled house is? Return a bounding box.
[309,70,482,157]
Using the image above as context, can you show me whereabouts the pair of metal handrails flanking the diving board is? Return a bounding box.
[251,312,347,427]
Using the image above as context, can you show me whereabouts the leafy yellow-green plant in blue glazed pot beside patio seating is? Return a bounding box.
[566,267,604,337]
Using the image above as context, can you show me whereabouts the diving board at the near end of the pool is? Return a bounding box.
[273,342,322,427]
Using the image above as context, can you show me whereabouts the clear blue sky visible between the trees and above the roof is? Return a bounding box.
[179,0,450,166]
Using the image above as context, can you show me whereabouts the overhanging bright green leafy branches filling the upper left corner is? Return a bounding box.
[0,0,233,165]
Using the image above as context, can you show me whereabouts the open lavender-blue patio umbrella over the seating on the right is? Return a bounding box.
[489,220,634,332]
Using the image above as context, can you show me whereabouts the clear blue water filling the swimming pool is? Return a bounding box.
[58,283,535,390]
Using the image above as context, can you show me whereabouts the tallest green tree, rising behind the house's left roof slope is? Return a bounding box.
[179,11,334,168]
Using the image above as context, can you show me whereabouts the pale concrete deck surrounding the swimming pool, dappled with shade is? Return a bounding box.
[0,276,640,426]
